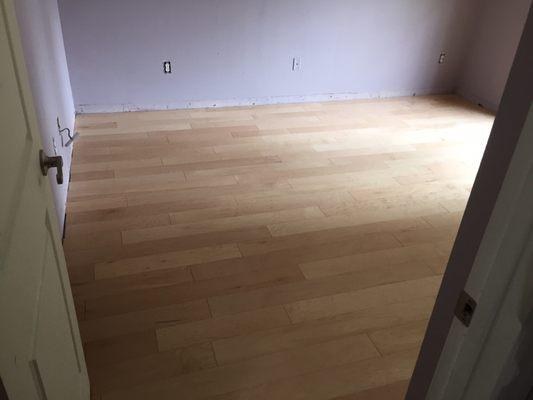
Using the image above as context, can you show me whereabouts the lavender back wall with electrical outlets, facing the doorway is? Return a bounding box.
[60,0,477,111]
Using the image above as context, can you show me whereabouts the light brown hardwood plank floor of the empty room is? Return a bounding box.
[65,96,493,400]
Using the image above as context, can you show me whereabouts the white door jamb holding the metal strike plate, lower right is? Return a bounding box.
[427,104,533,400]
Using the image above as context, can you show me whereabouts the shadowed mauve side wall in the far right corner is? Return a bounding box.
[458,0,531,110]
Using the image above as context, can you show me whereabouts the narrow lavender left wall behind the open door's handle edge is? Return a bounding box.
[15,0,75,227]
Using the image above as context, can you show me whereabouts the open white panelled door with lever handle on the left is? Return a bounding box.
[0,0,89,400]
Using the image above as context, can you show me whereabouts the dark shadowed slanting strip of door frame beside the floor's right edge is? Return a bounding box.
[406,3,533,400]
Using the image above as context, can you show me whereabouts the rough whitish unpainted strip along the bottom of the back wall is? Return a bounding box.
[76,89,451,114]
